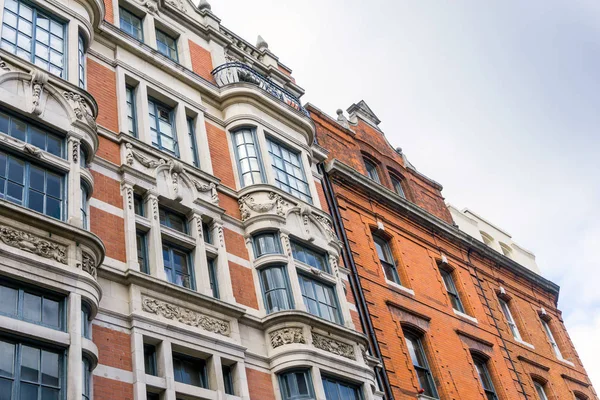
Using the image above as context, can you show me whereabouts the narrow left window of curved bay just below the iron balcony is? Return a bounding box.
[233,128,263,187]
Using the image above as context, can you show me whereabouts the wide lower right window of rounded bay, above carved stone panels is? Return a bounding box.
[298,275,342,324]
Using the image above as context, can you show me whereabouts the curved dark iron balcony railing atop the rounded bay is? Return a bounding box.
[211,62,310,117]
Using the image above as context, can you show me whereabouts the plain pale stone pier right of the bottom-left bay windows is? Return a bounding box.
[67,292,83,399]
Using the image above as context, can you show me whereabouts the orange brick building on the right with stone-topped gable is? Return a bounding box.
[307,101,598,400]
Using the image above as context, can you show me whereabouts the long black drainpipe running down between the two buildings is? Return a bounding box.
[317,163,394,400]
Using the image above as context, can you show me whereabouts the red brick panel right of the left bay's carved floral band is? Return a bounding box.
[90,207,127,262]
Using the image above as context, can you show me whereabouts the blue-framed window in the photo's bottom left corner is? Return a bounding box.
[0,340,64,399]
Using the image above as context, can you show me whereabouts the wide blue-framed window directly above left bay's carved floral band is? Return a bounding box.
[0,152,65,219]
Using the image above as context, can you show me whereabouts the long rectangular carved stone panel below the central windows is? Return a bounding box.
[142,297,230,336]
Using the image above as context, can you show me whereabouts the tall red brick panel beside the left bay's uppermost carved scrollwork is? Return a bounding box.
[87,58,119,132]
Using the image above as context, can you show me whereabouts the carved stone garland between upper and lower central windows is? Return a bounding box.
[125,143,219,205]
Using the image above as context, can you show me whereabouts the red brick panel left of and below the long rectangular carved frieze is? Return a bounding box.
[92,325,133,372]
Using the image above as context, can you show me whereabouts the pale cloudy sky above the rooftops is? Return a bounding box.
[209,0,600,389]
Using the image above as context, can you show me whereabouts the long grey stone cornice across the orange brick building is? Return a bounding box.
[325,159,560,301]
